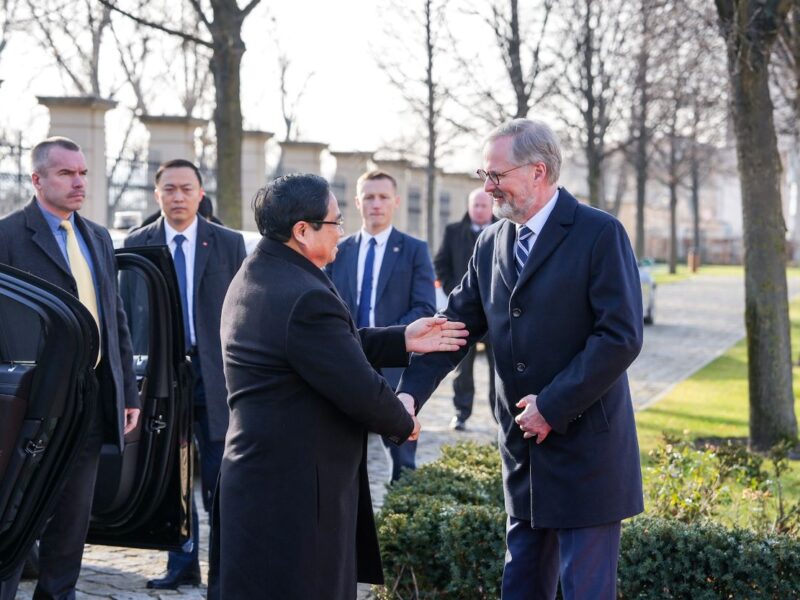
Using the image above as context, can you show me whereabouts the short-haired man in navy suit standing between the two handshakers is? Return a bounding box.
[328,171,436,482]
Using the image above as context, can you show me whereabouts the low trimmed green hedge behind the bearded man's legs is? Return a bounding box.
[376,443,800,600]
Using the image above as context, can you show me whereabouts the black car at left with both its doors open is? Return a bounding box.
[0,247,192,578]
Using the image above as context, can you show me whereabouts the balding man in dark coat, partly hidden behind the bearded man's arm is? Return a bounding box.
[433,188,497,431]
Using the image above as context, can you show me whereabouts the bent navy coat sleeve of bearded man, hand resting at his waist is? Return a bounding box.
[537,220,643,433]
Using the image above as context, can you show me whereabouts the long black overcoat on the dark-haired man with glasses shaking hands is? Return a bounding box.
[217,238,413,600]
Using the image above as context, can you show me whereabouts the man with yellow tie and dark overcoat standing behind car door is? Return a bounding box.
[0,137,140,600]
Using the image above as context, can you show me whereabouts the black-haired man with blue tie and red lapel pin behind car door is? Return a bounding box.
[125,159,245,589]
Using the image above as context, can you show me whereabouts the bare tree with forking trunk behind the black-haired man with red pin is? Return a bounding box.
[98,0,261,226]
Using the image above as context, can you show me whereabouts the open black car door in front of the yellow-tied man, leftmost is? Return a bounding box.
[0,265,98,578]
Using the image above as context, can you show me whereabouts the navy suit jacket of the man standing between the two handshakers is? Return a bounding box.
[326,228,436,388]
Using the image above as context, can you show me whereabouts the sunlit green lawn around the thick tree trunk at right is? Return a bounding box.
[636,296,800,524]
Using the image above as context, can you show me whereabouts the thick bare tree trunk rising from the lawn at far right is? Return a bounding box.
[715,0,797,450]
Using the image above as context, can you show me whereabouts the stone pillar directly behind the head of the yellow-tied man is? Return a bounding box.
[37,96,117,226]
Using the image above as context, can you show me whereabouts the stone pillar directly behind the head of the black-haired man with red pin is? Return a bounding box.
[139,115,209,218]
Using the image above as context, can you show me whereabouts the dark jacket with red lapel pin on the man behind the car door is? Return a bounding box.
[125,217,246,441]
